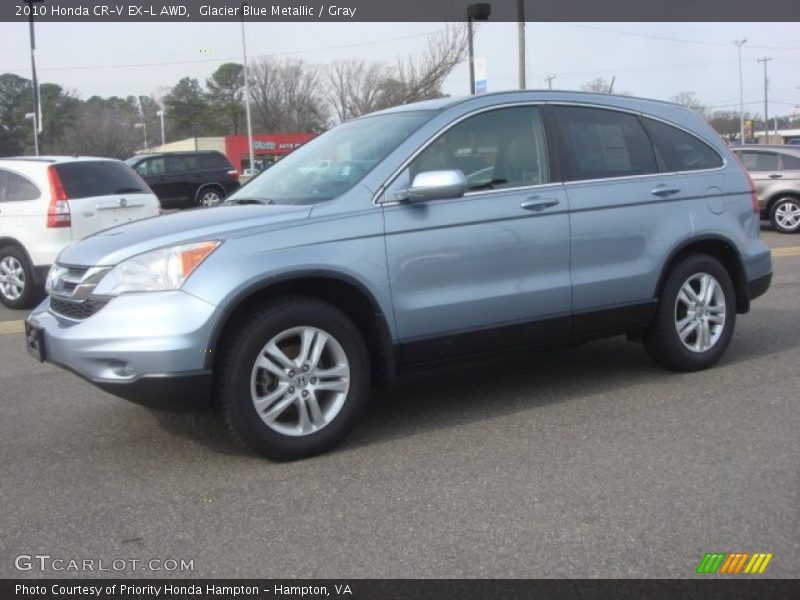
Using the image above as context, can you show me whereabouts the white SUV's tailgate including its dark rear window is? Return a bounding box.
[55,160,160,239]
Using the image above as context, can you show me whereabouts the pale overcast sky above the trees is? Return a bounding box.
[0,22,800,116]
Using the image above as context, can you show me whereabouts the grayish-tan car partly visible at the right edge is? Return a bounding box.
[733,146,800,233]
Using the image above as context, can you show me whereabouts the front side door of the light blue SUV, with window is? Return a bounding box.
[384,106,571,363]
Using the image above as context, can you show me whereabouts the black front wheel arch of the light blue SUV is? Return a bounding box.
[206,270,395,385]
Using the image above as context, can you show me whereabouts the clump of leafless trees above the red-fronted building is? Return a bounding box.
[250,57,328,133]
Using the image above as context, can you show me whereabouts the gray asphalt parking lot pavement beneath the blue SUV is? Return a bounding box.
[0,233,800,578]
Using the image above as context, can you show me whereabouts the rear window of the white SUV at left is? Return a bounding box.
[56,160,151,198]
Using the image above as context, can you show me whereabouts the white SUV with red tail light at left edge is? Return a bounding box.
[0,156,160,308]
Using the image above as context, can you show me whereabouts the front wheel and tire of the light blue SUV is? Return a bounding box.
[214,296,370,460]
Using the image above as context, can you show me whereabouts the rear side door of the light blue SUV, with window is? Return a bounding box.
[552,105,691,335]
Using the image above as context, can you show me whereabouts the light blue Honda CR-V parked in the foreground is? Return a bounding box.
[26,92,772,459]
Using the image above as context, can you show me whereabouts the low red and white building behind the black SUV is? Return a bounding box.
[142,133,316,171]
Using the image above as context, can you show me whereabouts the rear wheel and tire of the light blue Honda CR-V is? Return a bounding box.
[642,254,736,371]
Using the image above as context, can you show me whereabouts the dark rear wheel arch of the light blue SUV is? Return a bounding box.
[655,234,750,314]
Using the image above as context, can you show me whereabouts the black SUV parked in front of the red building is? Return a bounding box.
[126,150,239,208]
